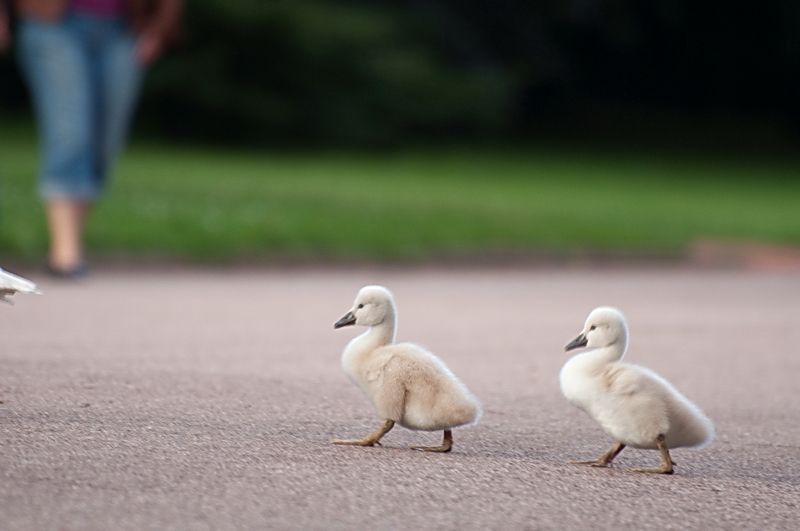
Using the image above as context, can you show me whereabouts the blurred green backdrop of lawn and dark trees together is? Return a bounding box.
[0,0,800,264]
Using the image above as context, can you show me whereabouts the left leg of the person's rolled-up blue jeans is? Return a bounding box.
[18,19,97,200]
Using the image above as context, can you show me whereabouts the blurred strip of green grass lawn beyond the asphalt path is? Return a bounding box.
[0,128,800,262]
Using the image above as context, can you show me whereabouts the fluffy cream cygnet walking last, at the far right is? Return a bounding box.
[560,307,714,474]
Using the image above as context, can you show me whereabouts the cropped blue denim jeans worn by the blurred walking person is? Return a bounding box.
[17,13,142,201]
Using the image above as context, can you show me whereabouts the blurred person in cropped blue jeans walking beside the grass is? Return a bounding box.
[0,0,183,278]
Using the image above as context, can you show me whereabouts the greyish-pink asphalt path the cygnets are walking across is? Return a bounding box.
[0,267,800,531]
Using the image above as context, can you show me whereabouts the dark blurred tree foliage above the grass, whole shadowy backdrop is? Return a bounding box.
[0,0,800,146]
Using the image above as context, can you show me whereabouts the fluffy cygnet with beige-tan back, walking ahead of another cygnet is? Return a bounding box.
[333,286,481,452]
